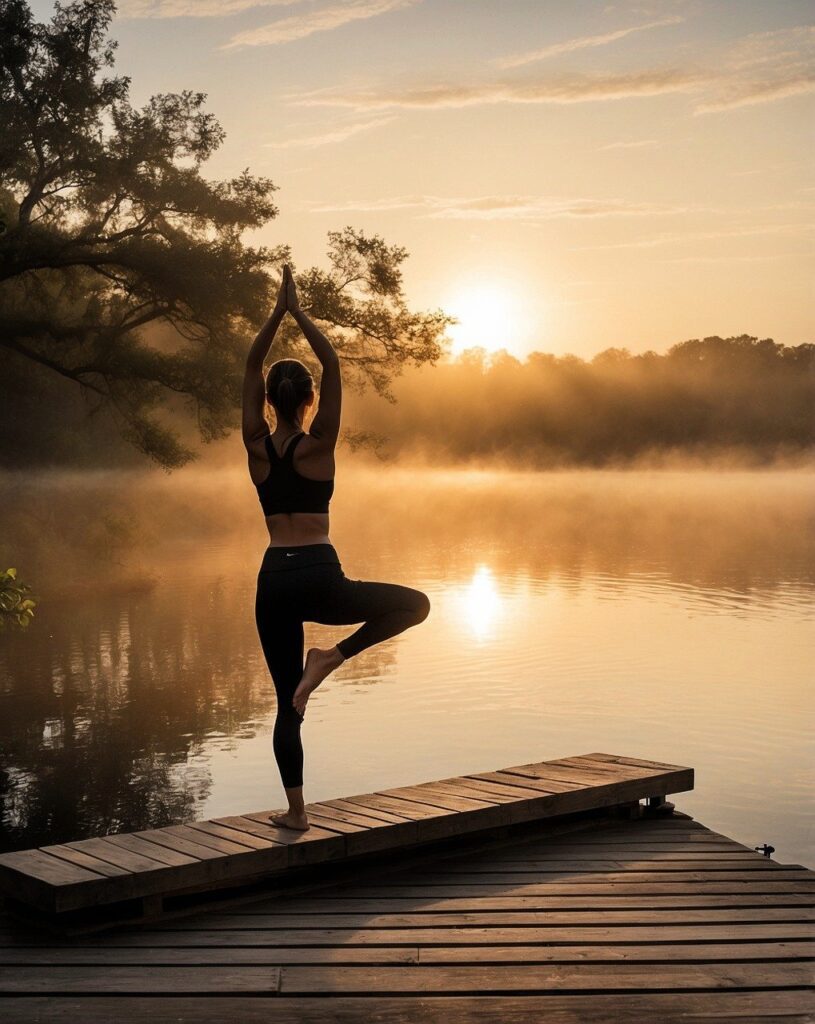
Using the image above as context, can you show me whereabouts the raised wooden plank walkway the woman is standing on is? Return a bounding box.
[0,754,693,927]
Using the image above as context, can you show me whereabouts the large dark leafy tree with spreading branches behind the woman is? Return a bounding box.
[0,0,452,468]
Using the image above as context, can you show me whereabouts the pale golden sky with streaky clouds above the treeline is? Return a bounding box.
[32,0,815,358]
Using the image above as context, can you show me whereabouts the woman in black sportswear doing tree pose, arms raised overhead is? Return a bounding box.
[243,264,430,830]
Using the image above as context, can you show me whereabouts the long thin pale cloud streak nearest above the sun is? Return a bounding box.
[298,195,685,221]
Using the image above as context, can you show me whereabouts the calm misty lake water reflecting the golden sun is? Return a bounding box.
[0,469,815,866]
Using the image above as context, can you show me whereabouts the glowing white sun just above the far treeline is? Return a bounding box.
[442,278,529,355]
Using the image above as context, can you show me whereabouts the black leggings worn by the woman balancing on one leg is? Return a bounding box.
[255,544,430,790]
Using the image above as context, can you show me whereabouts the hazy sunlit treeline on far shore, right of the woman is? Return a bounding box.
[347,335,815,466]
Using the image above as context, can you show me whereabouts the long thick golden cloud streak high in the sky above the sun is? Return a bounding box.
[288,70,704,110]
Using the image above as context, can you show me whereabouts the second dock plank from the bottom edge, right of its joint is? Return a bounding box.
[278,963,812,995]
